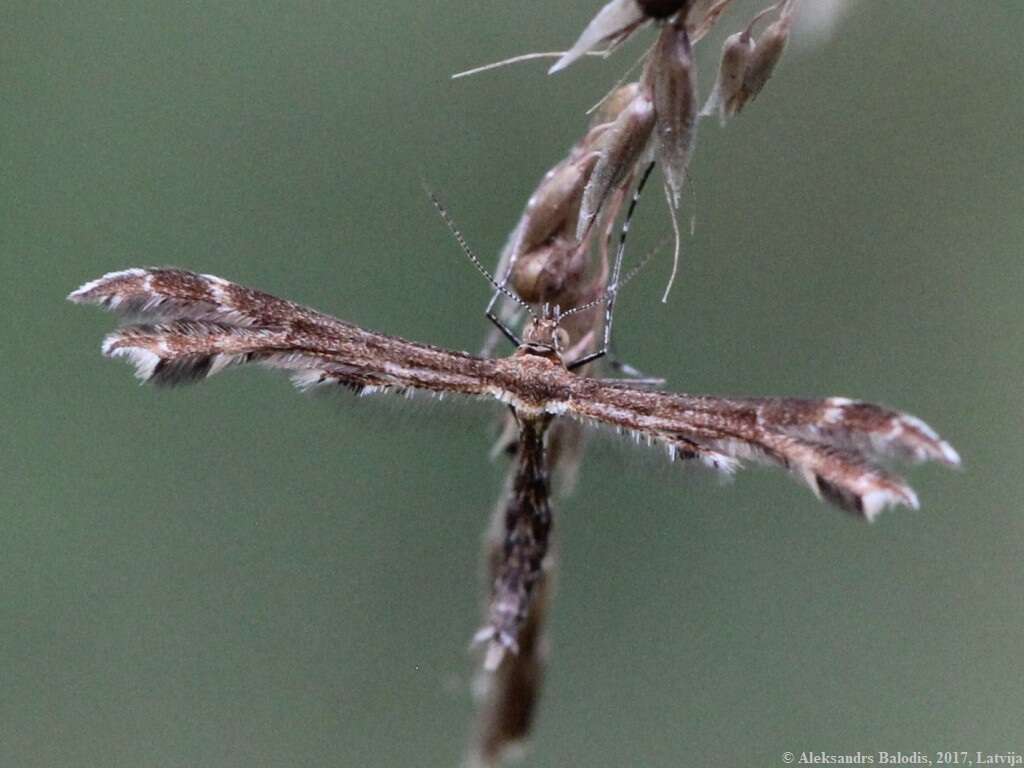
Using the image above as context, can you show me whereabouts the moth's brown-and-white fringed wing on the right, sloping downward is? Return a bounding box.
[566,378,959,519]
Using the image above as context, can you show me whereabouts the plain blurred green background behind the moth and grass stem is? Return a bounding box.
[0,0,1024,768]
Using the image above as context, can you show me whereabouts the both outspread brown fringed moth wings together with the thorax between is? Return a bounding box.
[69,269,959,519]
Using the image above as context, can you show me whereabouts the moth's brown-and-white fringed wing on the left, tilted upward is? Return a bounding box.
[68,269,494,395]
